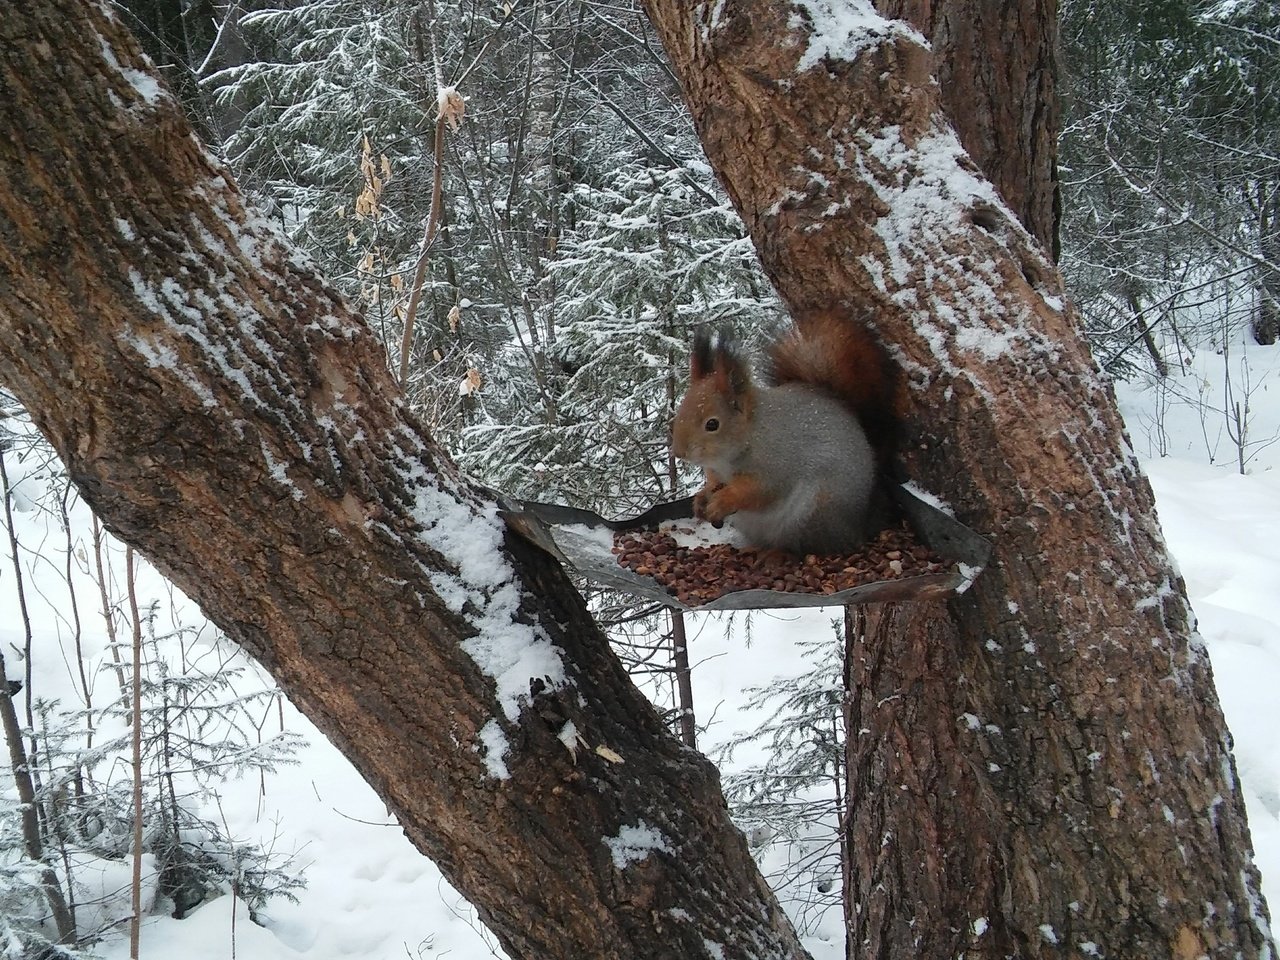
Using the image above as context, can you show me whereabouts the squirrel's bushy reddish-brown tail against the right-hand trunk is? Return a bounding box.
[768,311,899,470]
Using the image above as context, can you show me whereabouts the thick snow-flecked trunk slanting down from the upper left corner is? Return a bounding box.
[0,0,804,960]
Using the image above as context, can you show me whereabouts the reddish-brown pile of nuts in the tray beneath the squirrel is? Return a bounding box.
[613,527,950,607]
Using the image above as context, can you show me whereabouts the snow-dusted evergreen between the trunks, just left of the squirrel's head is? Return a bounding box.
[460,160,778,515]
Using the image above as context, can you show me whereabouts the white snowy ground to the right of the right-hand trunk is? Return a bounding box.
[1116,344,1280,905]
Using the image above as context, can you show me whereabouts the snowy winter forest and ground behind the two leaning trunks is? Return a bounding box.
[0,0,1280,957]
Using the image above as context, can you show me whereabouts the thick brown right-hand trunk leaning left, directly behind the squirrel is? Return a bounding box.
[646,0,1274,960]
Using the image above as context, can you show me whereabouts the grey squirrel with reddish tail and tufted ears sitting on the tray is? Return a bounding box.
[672,311,897,554]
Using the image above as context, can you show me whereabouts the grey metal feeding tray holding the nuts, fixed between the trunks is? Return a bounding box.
[503,486,991,611]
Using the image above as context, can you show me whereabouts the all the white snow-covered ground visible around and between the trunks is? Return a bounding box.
[0,348,1280,960]
